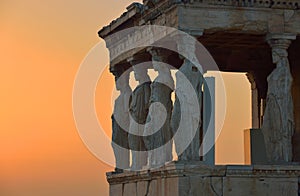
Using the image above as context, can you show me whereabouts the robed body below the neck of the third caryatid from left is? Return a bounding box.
[144,81,173,167]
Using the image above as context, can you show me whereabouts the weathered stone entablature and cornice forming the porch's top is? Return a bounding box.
[99,0,300,69]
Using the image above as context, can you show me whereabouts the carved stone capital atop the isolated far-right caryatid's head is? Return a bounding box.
[266,33,296,50]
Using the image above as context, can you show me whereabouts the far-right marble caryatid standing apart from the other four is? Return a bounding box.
[262,48,294,162]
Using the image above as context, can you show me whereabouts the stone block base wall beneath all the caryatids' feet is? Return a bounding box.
[107,162,300,196]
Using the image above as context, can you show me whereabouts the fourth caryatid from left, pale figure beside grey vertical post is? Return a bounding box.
[171,37,203,161]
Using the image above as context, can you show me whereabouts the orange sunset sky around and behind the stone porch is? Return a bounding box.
[0,0,251,196]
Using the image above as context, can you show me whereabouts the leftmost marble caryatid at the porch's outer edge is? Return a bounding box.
[112,71,132,172]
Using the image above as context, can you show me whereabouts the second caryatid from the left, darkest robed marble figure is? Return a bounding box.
[128,65,151,170]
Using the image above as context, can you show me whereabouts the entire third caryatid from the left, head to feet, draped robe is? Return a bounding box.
[144,50,174,168]
